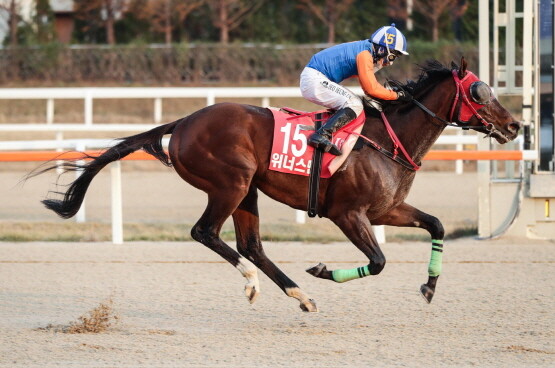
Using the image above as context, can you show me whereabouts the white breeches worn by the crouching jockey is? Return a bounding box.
[300,68,364,116]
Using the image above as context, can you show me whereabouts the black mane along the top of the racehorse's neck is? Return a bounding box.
[363,59,458,115]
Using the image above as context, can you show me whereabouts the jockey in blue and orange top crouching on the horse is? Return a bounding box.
[300,24,412,156]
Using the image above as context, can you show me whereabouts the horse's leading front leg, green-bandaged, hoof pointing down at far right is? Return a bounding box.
[372,203,445,303]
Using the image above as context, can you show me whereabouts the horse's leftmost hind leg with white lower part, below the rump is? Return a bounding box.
[191,188,260,302]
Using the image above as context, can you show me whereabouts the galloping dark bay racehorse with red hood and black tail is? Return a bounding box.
[32,58,521,312]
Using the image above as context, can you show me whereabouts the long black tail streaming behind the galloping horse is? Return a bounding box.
[39,118,185,219]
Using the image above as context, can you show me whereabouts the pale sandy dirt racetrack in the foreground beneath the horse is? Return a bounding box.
[0,239,555,367]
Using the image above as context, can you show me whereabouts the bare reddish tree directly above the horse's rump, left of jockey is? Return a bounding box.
[207,0,264,43]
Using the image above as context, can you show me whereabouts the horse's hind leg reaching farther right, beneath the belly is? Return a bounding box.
[233,185,318,312]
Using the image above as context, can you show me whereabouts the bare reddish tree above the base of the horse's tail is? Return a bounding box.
[134,0,205,44]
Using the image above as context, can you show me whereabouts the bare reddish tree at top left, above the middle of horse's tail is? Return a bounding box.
[75,0,128,45]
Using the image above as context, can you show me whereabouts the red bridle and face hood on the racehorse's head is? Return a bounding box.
[413,69,496,135]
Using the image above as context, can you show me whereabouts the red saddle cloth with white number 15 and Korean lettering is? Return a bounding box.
[269,108,365,178]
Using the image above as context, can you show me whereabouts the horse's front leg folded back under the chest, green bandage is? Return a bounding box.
[306,210,385,282]
